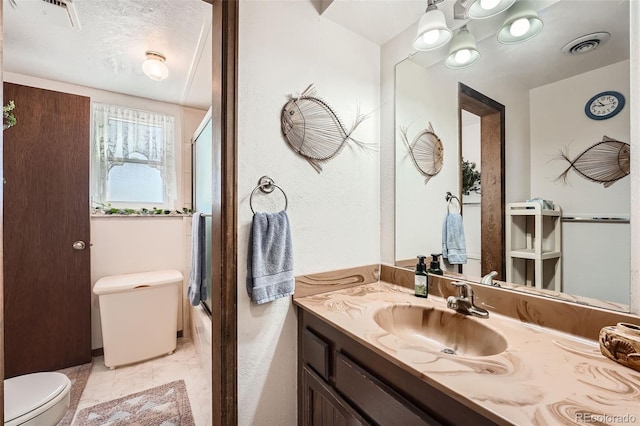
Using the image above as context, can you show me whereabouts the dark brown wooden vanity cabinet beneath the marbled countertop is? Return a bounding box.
[298,307,495,426]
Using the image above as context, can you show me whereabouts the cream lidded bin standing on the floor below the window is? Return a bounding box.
[93,269,183,368]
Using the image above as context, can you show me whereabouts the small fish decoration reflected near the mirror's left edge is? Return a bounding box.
[400,123,444,185]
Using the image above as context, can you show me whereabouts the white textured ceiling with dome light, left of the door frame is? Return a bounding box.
[3,0,211,109]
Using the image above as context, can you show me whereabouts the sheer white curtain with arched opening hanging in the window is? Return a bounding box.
[91,103,177,209]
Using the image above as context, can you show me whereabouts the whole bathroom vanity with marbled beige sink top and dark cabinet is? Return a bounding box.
[295,281,640,425]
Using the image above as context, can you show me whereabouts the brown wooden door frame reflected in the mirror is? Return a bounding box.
[458,83,505,280]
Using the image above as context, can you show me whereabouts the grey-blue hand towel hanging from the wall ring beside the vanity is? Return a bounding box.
[247,211,295,304]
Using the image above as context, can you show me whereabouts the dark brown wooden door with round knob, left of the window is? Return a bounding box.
[3,83,91,378]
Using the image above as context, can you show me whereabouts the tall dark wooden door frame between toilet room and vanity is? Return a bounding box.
[0,0,239,425]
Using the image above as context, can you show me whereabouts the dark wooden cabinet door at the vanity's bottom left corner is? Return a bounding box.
[299,367,369,426]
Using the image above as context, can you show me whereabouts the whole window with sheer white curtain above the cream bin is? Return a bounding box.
[91,103,177,209]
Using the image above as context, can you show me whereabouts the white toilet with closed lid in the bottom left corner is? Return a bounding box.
[4,372,71,426]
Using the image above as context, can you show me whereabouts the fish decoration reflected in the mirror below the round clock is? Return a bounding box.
[556,135,631,188]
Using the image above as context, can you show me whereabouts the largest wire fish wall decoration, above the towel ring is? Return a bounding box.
[280,84,373,173]
